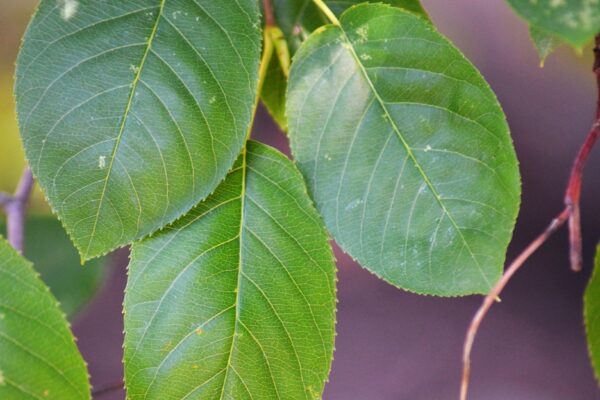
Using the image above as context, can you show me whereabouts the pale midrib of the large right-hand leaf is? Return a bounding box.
[335,24,492,288]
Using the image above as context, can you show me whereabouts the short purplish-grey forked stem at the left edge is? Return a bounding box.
[0,168,33,253]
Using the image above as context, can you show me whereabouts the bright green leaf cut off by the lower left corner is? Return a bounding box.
[0,239,90,400]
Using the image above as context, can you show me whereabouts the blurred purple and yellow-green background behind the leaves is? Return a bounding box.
[0,0,600,400]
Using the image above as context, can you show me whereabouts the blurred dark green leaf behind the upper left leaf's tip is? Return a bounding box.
[0,216,107,318]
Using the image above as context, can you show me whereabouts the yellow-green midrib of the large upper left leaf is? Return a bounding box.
[83,0,166,260]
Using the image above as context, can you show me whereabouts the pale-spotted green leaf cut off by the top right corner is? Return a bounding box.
[507,0,600,48]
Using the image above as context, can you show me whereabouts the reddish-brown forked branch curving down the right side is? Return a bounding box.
[460,35,600,400]
